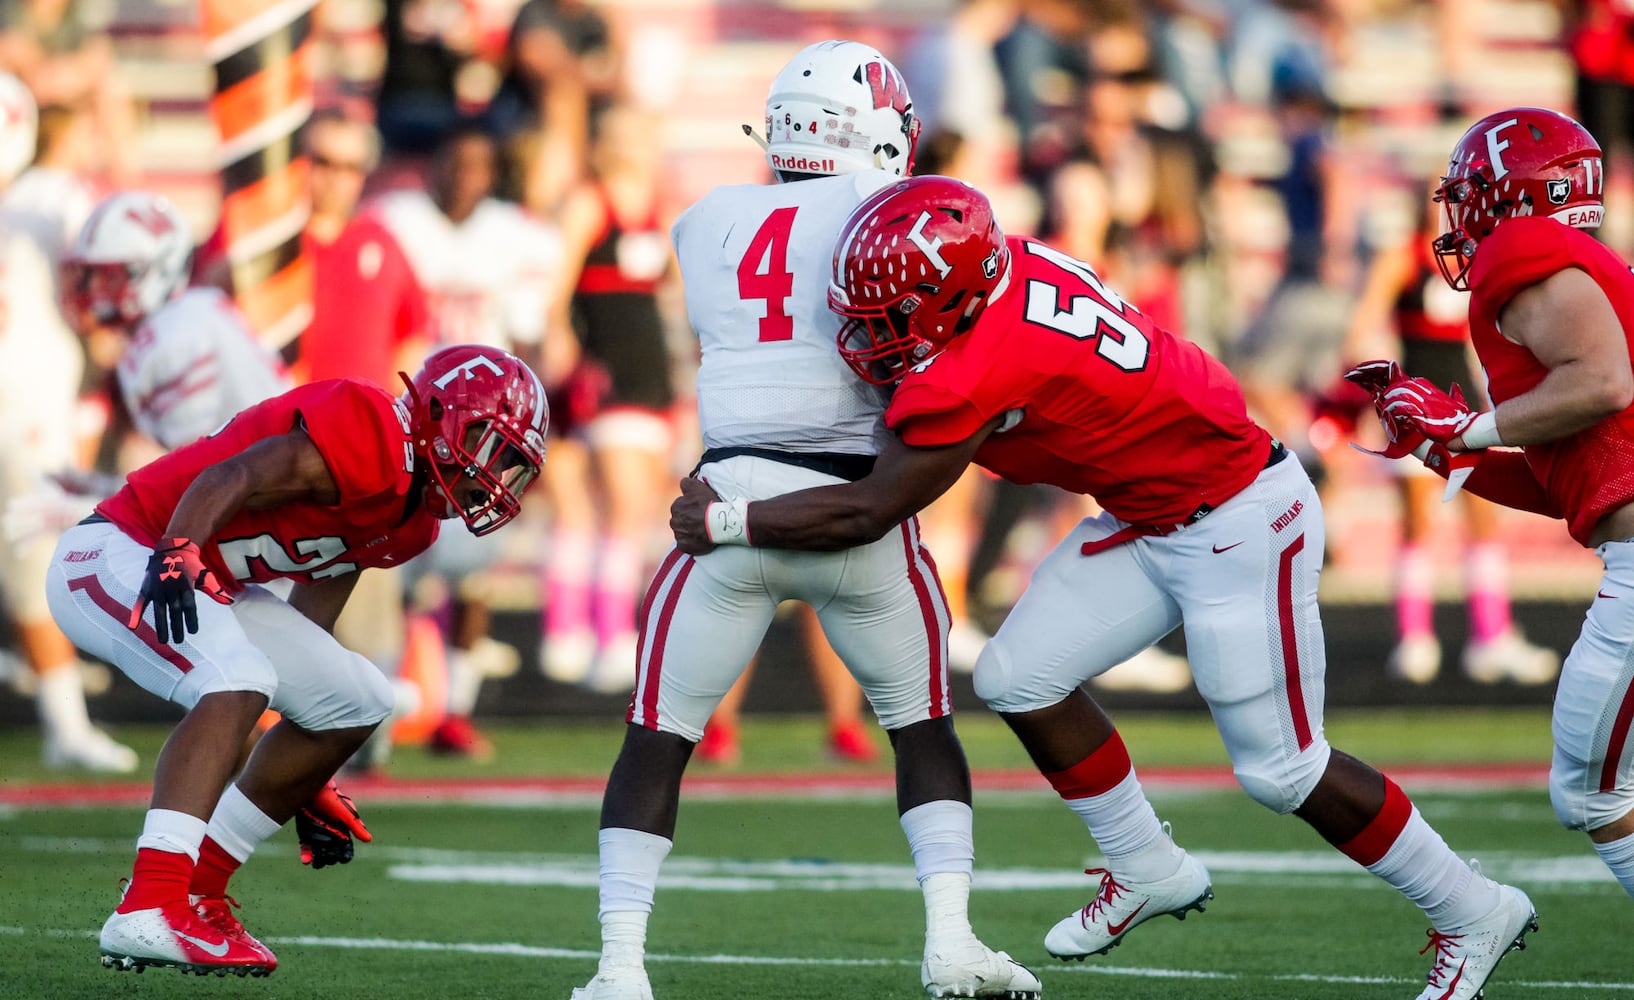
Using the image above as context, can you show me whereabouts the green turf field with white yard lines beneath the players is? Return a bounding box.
[0,712,1634,1000]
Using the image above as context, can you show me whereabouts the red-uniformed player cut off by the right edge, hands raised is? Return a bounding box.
[1350,108,1634,895]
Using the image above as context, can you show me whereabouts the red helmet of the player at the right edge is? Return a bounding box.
[1435,108,1606,291]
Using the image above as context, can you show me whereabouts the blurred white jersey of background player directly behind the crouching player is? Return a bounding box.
[119,288,291,449]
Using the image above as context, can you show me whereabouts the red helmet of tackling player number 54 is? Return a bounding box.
[828,176,1010,386]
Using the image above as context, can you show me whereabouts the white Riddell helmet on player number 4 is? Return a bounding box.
[766,41,920,176]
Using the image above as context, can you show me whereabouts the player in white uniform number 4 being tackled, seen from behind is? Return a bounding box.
[574,41,1039,1000]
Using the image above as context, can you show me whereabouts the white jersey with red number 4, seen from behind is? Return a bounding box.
[670,170,897,454]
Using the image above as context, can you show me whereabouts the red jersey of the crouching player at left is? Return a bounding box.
[96,379,438,592]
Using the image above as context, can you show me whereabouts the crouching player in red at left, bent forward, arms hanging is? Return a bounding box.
[46,346,547,975]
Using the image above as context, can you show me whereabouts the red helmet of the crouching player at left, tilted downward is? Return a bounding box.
[402,345,551,534]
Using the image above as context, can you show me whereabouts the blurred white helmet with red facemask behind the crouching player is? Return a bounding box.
[62,191,193,327]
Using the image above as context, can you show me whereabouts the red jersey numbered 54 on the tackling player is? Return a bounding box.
[886,237,1271,525]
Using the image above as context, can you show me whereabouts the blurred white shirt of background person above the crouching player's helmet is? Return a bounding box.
[371,191,562,350]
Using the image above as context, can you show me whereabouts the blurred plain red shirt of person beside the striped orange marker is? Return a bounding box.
[297,216,426,389]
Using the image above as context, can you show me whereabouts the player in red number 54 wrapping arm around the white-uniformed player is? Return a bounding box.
[672,176,1536,1000]
